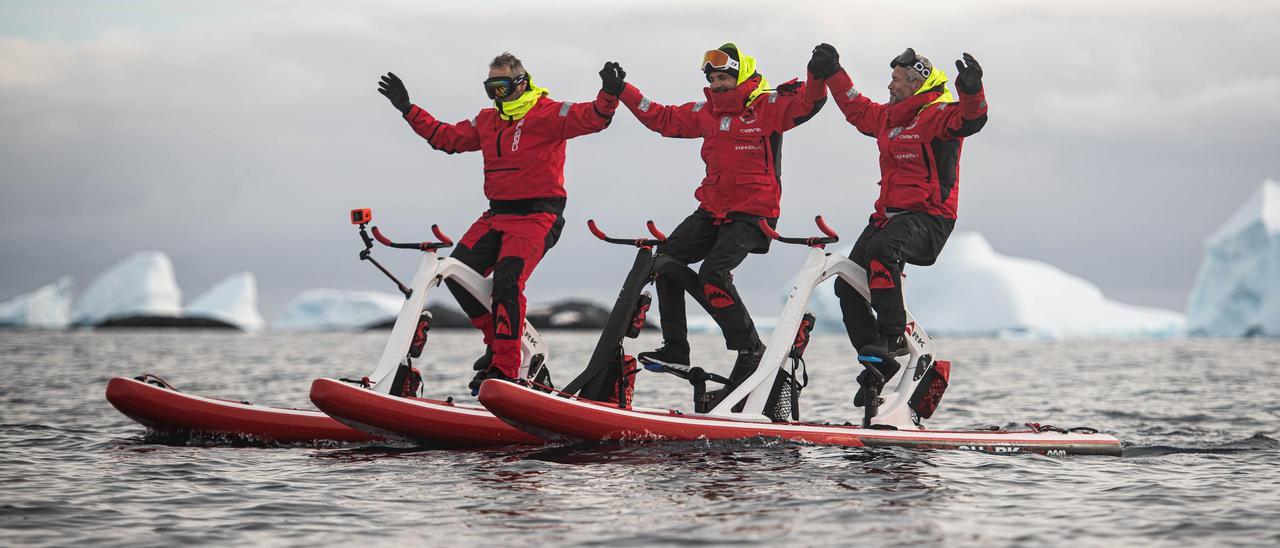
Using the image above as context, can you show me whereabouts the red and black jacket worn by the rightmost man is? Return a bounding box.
[827,70,987,222]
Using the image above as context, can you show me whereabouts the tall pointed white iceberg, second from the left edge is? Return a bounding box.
[72,251,182,325]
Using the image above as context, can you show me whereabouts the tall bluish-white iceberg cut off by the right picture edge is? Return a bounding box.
[1187,179,1280,337]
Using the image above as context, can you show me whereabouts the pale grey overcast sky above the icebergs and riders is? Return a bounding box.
[0,0,1280,319]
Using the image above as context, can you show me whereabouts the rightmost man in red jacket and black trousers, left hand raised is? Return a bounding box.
[814,44,987,389]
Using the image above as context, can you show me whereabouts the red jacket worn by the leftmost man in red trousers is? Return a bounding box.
[404,91,618,207]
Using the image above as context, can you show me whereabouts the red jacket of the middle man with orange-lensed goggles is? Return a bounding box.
[620,77,827,219]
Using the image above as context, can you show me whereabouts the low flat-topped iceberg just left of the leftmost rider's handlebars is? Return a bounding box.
[271,289,404,332]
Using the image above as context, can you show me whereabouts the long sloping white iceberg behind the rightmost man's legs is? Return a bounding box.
[803,232,1185,338]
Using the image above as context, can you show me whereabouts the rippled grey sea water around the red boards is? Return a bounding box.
[0,332,1280,545]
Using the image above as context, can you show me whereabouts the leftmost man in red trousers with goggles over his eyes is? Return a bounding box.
[379,52,623,392]
